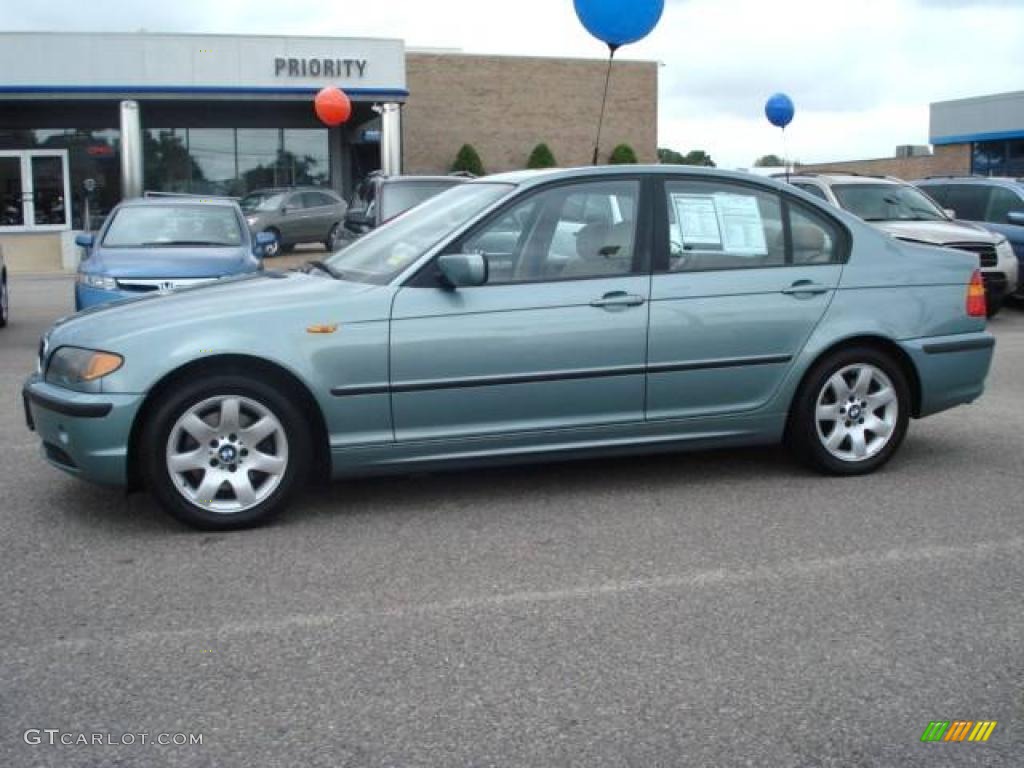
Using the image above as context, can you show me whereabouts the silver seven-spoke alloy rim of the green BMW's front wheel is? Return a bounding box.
[165,395,288,514]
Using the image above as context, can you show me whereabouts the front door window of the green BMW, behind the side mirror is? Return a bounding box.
[462,181,640,285]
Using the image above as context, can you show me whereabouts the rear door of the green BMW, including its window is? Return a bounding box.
[647,180,848,420]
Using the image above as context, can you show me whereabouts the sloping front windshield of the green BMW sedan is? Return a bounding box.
[327,181,515,285]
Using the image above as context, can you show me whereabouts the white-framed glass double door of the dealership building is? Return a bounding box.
[0,150,71,231]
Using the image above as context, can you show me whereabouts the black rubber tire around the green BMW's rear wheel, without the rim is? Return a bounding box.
[785,346,911,475]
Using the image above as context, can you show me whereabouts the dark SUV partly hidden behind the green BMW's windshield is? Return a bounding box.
[340,172,472,246]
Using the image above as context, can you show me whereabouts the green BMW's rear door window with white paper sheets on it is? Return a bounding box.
[666,181,785,272]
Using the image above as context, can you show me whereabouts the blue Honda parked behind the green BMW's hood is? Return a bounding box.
[75,198,273,309]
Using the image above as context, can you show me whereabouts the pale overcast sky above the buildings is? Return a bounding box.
[8,0,1024,167]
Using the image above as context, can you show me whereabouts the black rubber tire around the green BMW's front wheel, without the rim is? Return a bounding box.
[139,374,312,530]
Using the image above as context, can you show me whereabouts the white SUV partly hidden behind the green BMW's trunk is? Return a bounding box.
[790,174,1019,316]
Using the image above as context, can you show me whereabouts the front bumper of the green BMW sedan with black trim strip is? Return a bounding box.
[22,374,144,485]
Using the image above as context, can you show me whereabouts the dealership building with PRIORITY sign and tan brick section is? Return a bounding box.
[0,33,657,270]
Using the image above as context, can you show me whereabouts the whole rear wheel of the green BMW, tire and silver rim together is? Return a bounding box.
[786,347,910,475]
